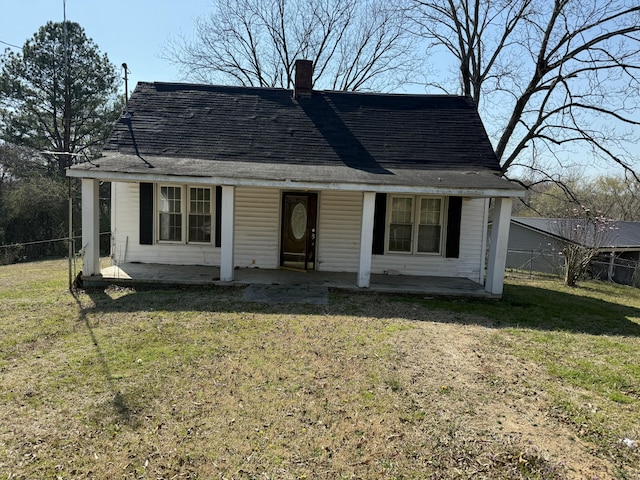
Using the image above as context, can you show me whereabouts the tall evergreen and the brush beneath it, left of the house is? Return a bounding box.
[0,22,123,263]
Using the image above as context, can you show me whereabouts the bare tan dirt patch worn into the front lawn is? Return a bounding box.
[395,313,613,479]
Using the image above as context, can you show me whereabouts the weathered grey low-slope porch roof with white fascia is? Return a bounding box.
[67,153,524,197]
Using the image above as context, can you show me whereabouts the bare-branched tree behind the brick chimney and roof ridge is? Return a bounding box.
[165,0,417,90]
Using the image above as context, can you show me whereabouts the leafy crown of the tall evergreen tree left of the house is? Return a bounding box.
[0,22,122,173]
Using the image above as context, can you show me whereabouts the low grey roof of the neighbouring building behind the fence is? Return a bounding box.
[511,217,640,249]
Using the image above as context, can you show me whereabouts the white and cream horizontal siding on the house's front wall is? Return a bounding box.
[112,182,486,281]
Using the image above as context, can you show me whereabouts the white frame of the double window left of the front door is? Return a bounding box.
[154,183,216,245]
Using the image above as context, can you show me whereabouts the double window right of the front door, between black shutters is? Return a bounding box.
[387,196,443,253]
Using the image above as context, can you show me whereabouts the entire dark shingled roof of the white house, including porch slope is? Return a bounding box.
[74,83,518,190]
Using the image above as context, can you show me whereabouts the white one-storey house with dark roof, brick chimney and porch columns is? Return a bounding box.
[67,60,523,295]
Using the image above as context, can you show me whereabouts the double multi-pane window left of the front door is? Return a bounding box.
[158,185,213,243]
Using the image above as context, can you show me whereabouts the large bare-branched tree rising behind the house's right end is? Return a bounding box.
[413,0,640,181]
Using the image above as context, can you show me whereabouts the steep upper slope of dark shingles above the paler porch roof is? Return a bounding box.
[105,83,499,172]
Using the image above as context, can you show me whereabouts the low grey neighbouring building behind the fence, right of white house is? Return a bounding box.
[507,217,640,285]
